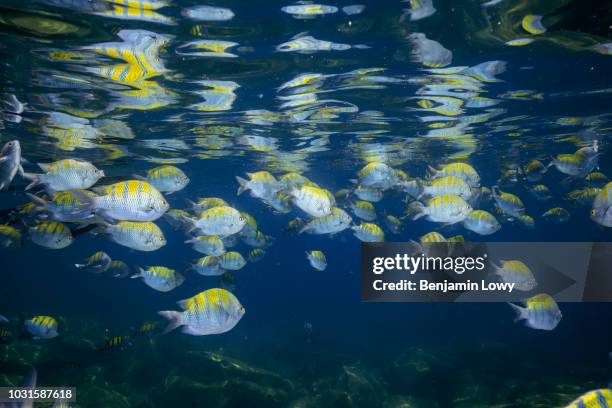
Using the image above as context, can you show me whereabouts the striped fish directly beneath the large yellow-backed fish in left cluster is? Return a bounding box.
[100,221,166,252]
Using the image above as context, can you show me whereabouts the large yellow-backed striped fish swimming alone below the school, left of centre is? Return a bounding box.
[158,288,245,336]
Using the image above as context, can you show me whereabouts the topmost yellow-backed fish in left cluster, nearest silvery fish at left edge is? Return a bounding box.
[23,159,104,192]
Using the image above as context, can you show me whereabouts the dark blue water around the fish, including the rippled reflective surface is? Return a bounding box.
[0,0,612,408]
